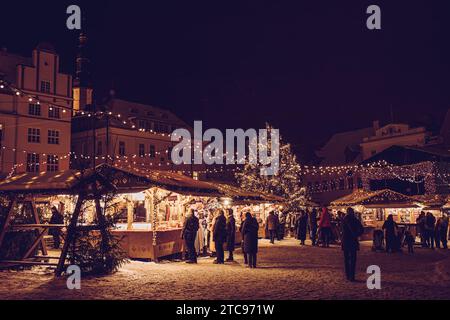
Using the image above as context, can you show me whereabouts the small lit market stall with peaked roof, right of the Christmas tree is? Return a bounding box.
[330,189,421,237]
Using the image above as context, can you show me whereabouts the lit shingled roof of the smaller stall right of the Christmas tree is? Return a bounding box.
[331,189,417,208]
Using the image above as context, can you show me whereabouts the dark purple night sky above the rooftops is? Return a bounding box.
[0,0,450,161]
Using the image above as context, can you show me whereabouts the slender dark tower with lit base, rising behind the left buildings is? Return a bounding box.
[73,31,93,112]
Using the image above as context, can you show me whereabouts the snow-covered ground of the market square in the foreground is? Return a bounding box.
[0,240,450,300]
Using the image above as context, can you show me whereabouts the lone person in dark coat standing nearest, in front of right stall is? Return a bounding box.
[342,208,364,281]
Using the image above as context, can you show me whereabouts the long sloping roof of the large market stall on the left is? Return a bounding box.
[0,164,283,202]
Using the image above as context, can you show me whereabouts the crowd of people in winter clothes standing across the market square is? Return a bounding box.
[182,208,449,281]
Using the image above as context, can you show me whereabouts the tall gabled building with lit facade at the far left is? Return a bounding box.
[0,43,72,175]
